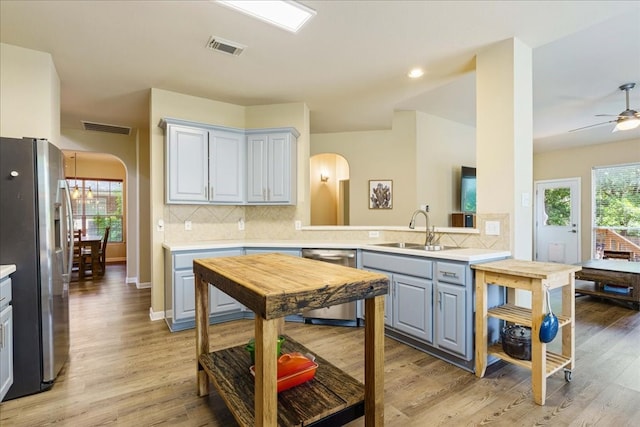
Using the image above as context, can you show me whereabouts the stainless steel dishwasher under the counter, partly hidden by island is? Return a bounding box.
[302,249,358,325]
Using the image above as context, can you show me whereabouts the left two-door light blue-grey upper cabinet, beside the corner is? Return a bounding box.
[162,119,246,204]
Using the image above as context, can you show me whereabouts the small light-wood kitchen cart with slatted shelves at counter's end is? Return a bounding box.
[471,259,580,405]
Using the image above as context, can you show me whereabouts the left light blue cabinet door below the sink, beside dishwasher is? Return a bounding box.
[393,274,433,342]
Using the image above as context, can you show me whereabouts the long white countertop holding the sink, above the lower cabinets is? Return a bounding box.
[162,240,511,262]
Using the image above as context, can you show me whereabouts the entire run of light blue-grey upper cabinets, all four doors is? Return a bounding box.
[160,118,299,205]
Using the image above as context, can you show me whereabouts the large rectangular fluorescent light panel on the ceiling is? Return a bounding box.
[216,0,316,33]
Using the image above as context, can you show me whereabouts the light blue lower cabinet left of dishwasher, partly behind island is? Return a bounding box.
[164,248,245,332]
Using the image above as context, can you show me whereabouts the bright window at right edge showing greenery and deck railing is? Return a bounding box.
[592,163,640,260]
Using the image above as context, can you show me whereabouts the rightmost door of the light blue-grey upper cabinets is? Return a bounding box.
[267,133,291,202]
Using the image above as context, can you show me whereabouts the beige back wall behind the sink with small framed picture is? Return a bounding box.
[311,111,476,227]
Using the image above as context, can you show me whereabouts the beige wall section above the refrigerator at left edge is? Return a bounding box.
[0,43,60,147]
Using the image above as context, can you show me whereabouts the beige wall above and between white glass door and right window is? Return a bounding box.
[533,138,640,260]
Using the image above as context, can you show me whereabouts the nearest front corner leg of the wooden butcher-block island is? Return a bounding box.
[255,316,283,427]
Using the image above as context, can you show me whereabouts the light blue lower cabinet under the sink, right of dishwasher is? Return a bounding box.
[362,250,482,371]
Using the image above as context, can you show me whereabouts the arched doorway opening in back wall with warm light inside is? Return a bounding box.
[309,153,349,225]
